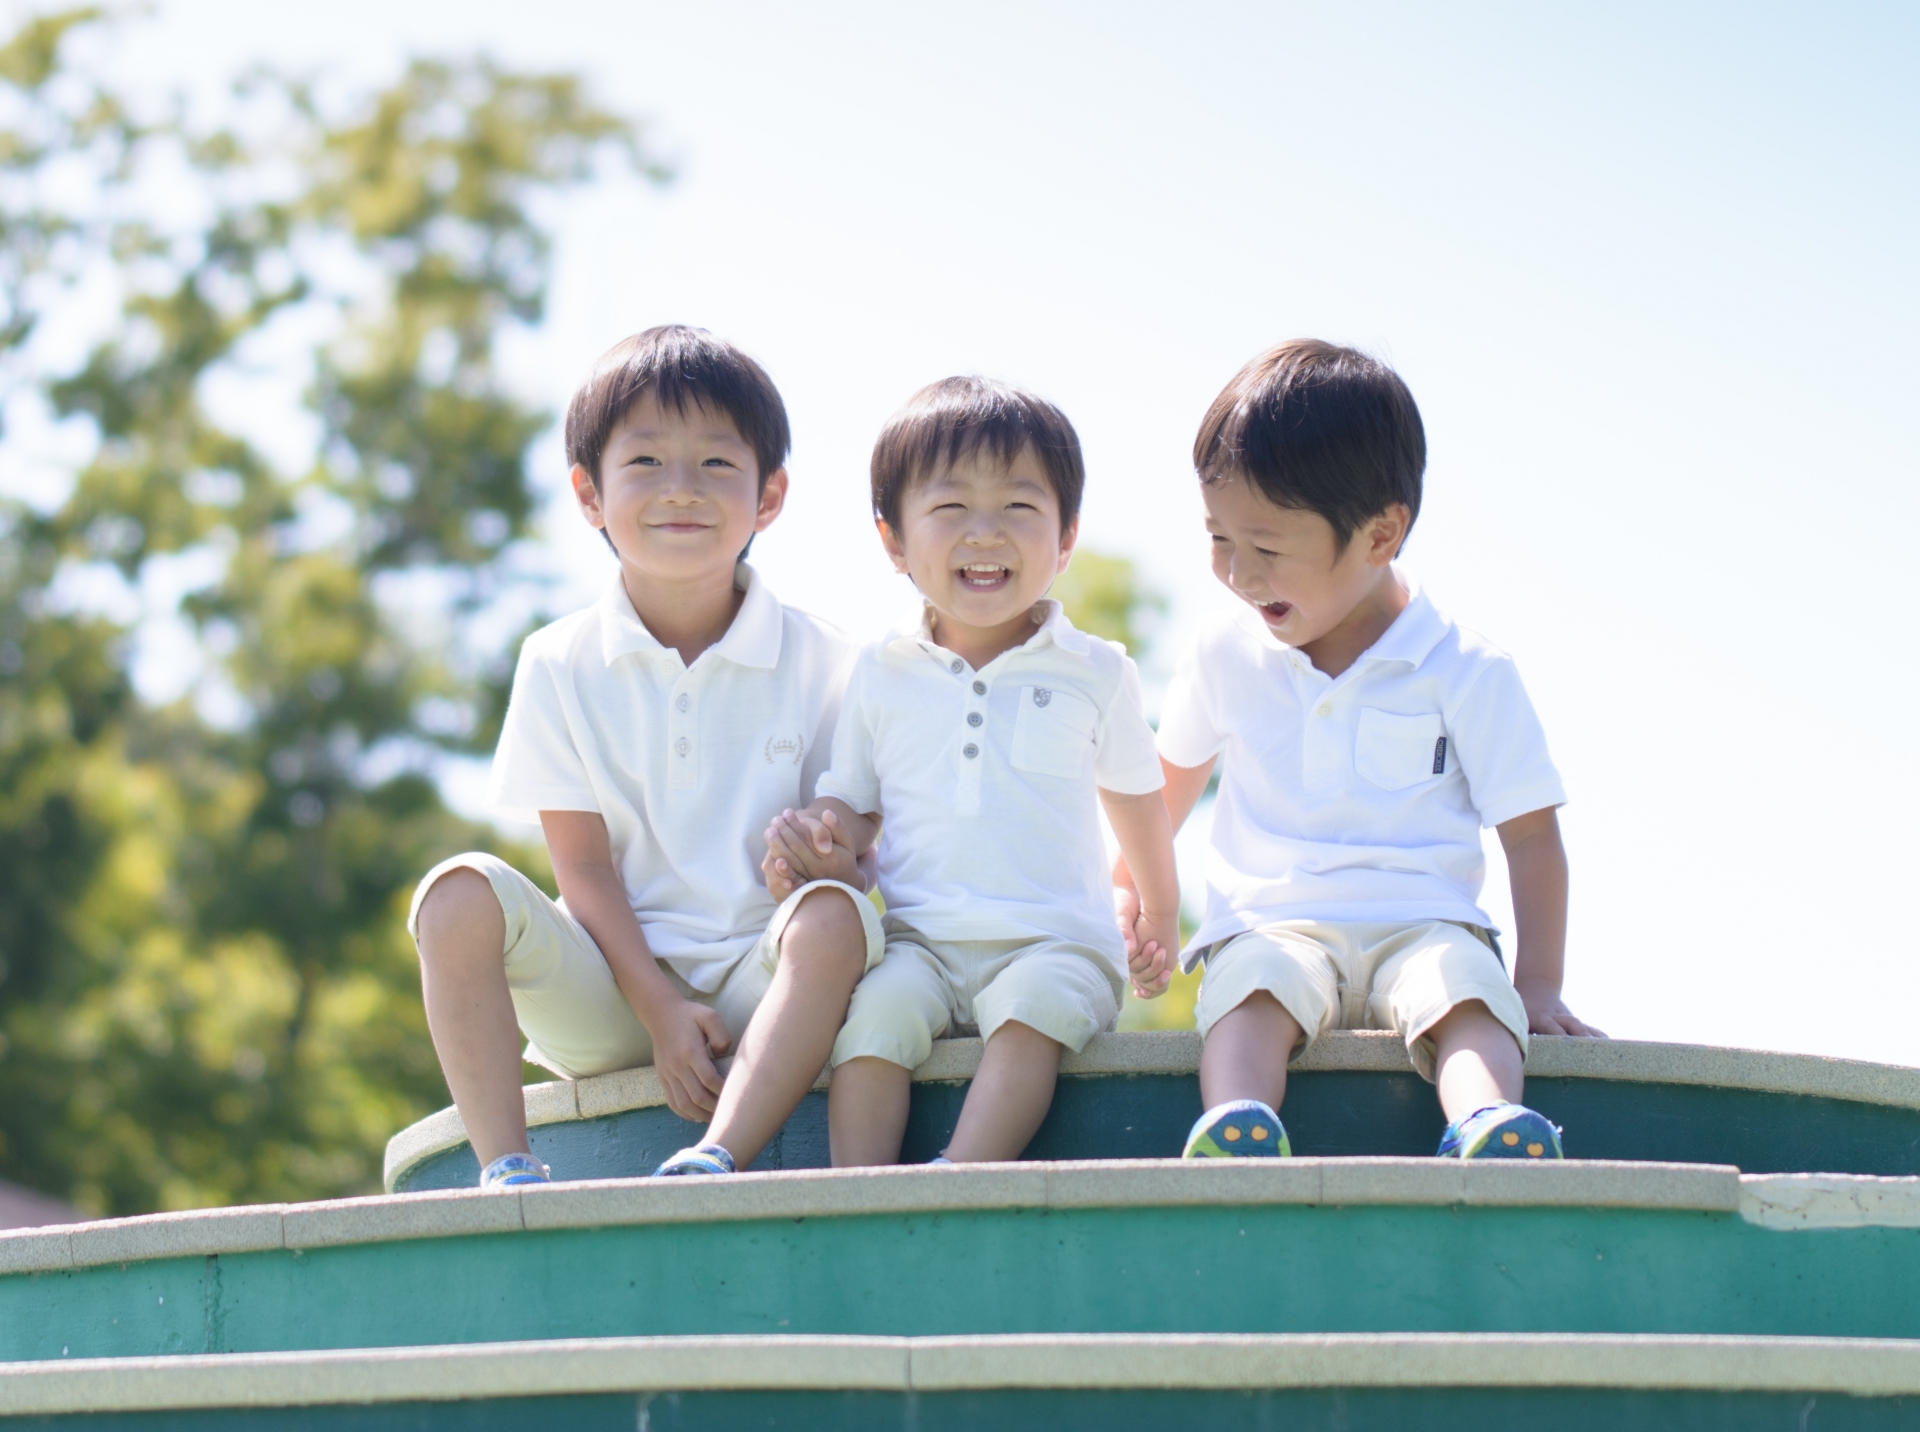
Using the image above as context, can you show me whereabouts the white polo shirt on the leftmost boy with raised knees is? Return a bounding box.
[488,562,854,992]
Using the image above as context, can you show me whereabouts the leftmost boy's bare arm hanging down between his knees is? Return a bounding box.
[540,810,730,1123]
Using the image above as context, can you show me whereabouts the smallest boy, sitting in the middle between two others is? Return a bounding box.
[766,378,1179,1165]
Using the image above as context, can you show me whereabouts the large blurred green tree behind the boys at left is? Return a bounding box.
[0,10,664,1213]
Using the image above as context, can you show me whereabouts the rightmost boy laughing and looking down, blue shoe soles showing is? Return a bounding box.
[1117,342,1599,1158]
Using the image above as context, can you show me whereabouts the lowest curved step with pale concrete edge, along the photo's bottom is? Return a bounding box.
[0,1332,1920,1432]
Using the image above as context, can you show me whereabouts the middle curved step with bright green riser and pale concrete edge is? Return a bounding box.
[0,1159,1920,1359]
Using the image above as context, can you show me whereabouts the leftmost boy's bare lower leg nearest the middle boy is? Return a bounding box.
[707,889,866,1169]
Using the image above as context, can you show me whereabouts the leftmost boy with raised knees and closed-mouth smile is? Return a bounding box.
[407,326,881,1188]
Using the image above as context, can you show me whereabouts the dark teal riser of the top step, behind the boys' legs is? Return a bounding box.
[397,1073,1920,1192]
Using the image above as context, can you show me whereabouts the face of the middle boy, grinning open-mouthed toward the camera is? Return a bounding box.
[879,447,1079,630]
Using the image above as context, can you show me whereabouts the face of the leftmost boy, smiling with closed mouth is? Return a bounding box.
[572,395,787,584]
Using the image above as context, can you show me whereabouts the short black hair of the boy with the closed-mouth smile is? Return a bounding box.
[566,322,793,491]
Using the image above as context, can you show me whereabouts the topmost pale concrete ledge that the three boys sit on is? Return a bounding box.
[384,1031,1920,1188]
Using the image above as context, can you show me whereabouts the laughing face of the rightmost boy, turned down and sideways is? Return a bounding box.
[1200,476,1409,647]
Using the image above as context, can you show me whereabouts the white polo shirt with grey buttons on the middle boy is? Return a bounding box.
[820,599,1164,962]
